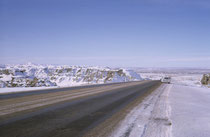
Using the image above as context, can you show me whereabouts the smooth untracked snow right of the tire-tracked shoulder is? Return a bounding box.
[169,85,210,137]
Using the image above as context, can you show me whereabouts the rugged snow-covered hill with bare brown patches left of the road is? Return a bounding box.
[0,63,142,88]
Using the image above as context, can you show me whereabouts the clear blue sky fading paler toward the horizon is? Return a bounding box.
[0,0,210,67]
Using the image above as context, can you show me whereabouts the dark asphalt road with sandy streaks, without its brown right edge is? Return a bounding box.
[0,81,160,137]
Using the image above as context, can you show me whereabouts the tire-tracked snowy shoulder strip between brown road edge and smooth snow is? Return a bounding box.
[112,84,172,137]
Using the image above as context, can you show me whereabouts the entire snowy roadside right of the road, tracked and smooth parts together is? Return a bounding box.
[112,84,210,137]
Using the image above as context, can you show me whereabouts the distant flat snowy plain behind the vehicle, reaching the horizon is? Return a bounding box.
[134,68,210,87]
